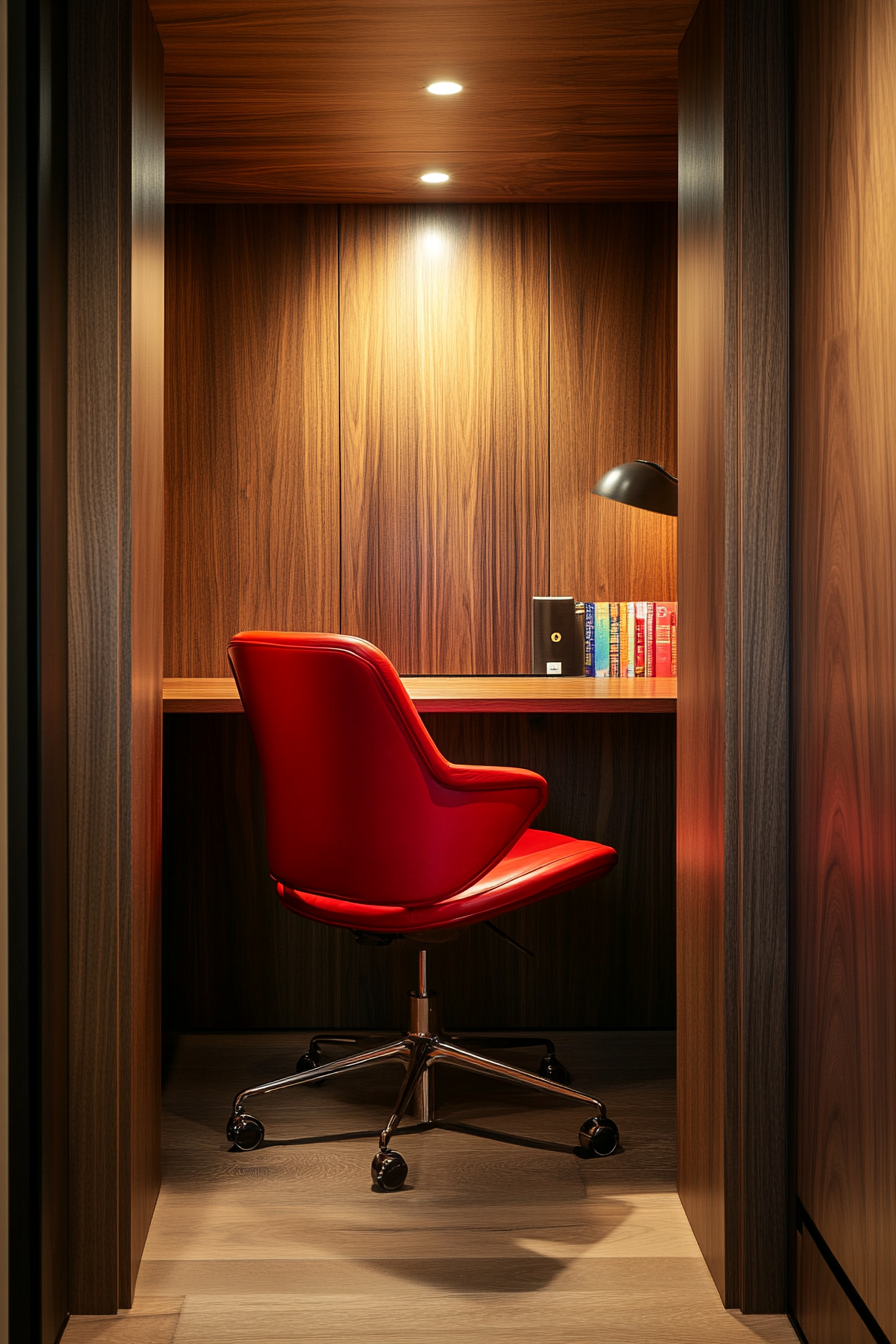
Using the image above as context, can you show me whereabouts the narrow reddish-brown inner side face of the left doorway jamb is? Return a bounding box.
[118,0,165,1308]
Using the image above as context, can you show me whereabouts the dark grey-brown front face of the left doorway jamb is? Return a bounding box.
[69,0,126,1312]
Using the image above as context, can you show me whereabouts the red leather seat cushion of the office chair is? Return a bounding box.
[277,829,617,933]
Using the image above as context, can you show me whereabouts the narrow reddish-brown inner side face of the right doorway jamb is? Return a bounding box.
[677,0,725,1293]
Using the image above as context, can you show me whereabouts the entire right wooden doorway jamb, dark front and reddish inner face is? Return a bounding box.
[678,0,789,1312]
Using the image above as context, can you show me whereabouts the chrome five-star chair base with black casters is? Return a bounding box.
[227,950,619,1191]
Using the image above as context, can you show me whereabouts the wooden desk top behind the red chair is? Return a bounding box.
[163,676,677,714]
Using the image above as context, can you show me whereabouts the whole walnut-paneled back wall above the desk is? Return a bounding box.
[165,204,676,676]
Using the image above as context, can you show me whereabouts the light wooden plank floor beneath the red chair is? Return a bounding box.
[63,1032,795,1344]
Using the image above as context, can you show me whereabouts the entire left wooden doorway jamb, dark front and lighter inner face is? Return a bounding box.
[69,0,164,1313]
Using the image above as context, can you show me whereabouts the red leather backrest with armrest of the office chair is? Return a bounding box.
[228,630,547,906]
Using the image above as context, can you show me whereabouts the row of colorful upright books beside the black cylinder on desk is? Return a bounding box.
[576,602,678,676]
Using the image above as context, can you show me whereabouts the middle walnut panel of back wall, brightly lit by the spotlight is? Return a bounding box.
[340,206,548,675]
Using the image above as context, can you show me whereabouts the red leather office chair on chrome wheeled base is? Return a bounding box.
[227,632,619,1189]
